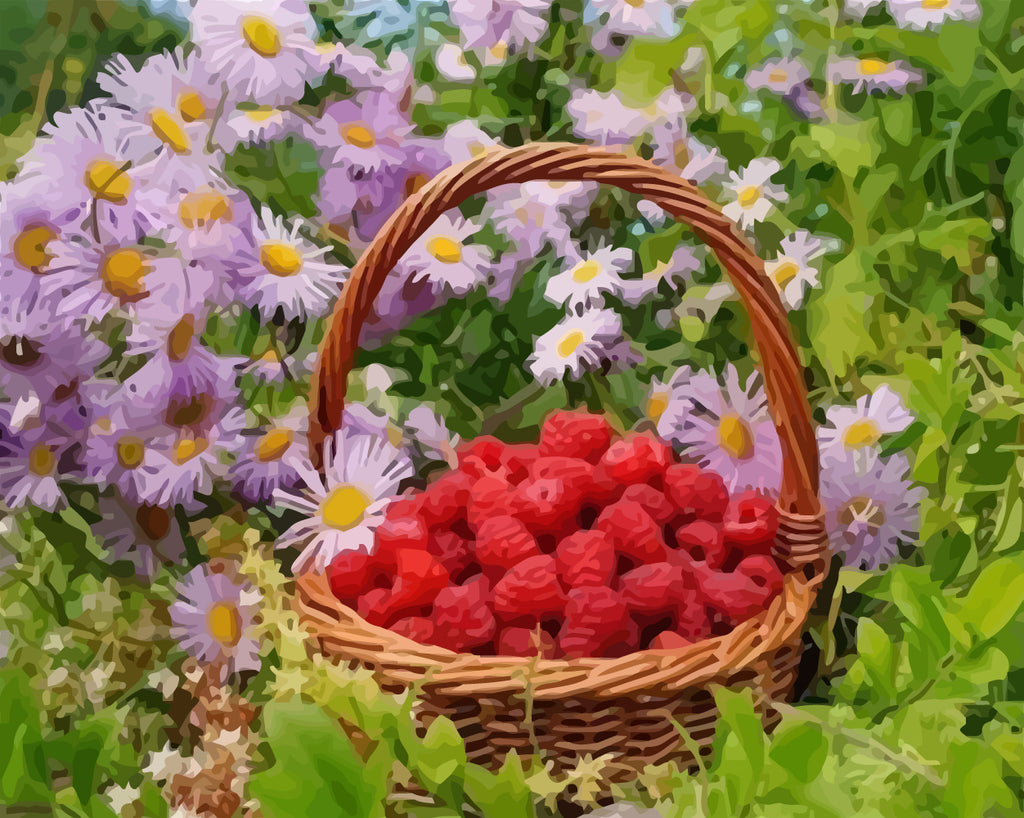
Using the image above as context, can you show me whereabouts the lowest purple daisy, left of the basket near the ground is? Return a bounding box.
[170,565,263,684]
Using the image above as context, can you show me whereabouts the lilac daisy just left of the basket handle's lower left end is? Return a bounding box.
[227,403,312,506]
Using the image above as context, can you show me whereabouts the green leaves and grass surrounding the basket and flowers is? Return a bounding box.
[0,0,1024,818]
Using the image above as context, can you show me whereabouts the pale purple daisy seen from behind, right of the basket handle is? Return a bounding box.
[821,455,925,570]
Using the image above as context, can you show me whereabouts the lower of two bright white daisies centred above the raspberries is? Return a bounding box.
[526,309,624,386]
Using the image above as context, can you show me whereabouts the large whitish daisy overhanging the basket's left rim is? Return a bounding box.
[274,432,413,574]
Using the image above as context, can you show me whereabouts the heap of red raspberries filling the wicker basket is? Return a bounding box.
[328,412,782,658]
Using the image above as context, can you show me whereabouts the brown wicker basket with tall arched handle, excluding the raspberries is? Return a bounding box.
[297,143,826,780]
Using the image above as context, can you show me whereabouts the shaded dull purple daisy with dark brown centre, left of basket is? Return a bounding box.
[91,497,185,579]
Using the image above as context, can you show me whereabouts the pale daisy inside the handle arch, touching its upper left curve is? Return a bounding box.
[397,215,490,295]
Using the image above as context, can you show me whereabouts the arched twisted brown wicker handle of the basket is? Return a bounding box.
[309,142,823,522]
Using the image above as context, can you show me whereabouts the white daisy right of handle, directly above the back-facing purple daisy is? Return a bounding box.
[818,384,913,471]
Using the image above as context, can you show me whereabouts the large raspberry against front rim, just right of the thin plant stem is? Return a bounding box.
[558,587,639,656]
